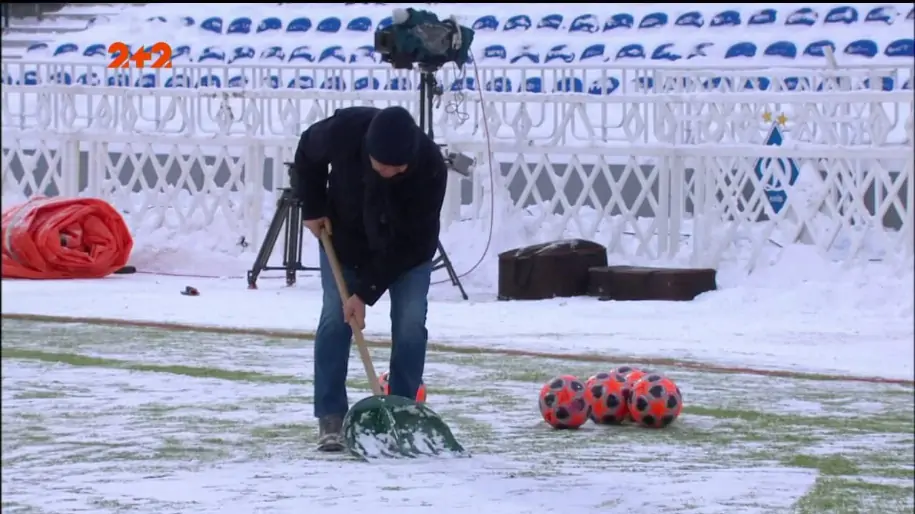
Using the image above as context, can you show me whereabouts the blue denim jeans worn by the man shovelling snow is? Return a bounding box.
[314,248,432,418]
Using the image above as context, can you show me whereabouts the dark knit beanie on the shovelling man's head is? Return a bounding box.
[365,106,419,166]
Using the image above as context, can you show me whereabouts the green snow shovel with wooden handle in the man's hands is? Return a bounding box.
[321,231,467,460]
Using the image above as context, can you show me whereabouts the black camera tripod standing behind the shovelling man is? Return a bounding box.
[247,69,468,300]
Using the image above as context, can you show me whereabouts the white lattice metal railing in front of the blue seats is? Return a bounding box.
[2,79,915,266]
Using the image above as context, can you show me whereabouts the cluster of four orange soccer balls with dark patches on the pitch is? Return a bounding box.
[540,366,683,428]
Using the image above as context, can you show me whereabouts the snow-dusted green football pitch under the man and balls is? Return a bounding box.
[2,320,915,514]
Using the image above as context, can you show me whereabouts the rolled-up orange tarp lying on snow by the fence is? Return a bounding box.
[0,197,133,279]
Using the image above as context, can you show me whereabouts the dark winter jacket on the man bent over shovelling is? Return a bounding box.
[292,107,448,305]
